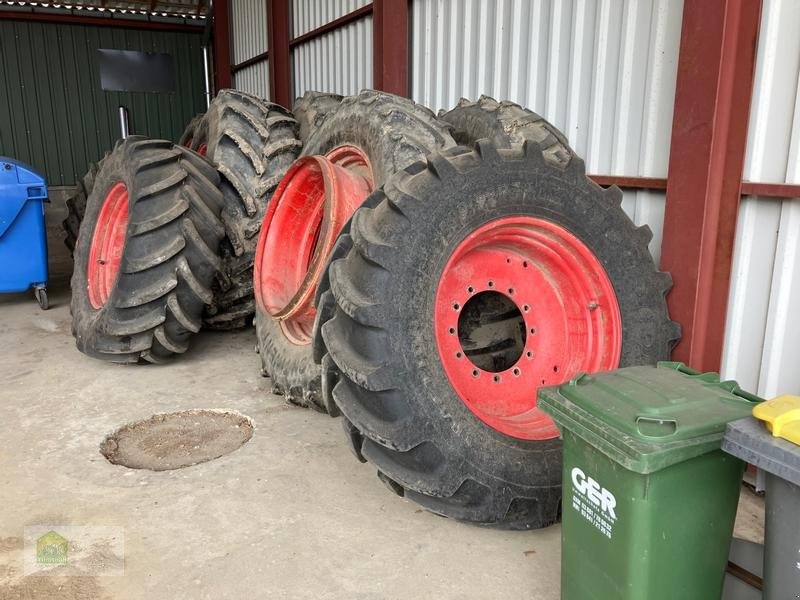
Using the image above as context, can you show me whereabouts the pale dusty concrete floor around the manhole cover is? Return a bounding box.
[0,195,763,599]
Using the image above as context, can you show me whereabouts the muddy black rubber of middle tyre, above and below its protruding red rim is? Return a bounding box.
[256,90,455,411]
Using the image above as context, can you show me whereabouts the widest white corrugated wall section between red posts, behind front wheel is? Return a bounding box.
[411,0,683,260]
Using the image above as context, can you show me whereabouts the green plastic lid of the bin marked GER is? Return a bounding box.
[538,362,762,473]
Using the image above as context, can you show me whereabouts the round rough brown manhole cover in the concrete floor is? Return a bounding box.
[100,410,253,471]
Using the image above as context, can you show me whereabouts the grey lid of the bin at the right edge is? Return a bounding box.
[722,417,800,486]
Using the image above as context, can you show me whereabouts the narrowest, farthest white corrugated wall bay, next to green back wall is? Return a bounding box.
[229,0,269,98]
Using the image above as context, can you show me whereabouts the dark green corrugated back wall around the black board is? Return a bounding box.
[0,20,205,185]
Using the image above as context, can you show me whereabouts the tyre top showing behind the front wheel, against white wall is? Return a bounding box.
[439,96,573,167]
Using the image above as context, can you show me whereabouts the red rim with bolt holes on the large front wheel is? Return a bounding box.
[434,216,622,440]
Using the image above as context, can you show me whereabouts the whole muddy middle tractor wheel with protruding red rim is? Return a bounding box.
[255,90,455,411]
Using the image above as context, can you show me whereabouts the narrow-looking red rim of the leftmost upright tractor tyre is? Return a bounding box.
[86,181,128,309]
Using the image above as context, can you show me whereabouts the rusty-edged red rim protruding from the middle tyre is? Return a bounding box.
[254,146,373,345]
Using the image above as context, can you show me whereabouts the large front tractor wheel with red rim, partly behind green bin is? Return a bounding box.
[315,140,680,529]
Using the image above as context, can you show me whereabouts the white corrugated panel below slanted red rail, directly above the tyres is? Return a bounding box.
[292,16,372,97]
